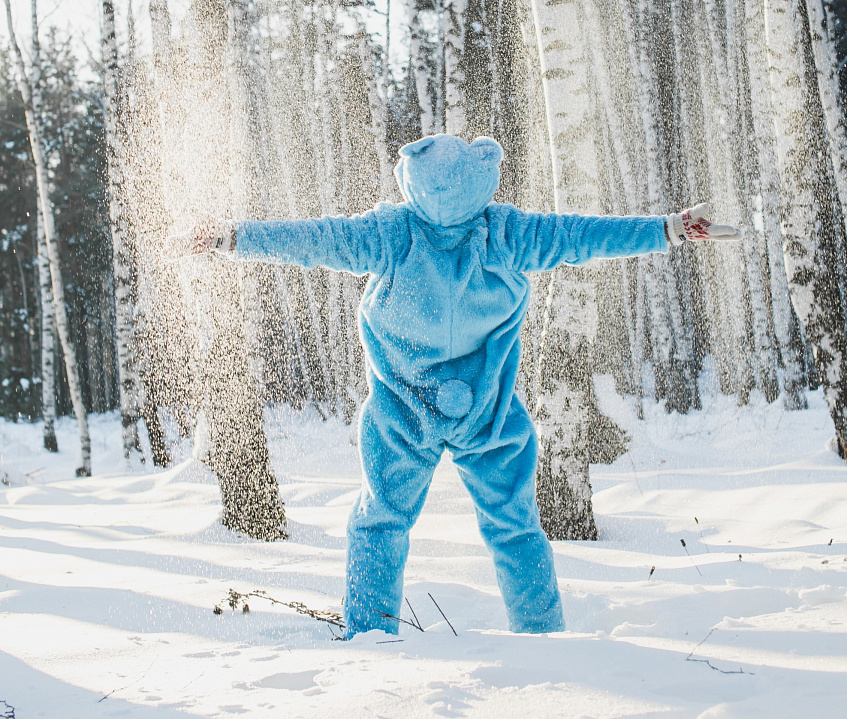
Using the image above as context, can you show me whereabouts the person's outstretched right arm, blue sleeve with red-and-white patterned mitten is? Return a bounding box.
[504,204,740,272]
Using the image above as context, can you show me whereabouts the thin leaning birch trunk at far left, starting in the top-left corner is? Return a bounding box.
[5,0,91,477]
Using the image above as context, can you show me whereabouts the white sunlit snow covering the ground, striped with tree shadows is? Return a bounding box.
[0,382,847,719]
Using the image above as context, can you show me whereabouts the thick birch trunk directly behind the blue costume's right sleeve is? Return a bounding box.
[533,0,601,539]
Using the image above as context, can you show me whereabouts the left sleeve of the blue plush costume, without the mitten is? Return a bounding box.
[234,210,389,275]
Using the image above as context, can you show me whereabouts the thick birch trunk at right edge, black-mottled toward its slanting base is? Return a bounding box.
[765,0,847,456]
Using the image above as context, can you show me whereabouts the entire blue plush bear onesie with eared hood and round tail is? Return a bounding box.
[235,135,667,635]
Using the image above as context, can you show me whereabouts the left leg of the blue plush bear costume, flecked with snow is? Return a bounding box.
[344,382,442,636]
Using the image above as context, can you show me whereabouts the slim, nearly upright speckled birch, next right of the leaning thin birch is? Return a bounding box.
[100,0,140,459]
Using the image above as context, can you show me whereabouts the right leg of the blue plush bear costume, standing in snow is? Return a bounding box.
[453,398,565,633]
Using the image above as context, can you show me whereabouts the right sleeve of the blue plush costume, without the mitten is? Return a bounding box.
[503,208,668,272]
